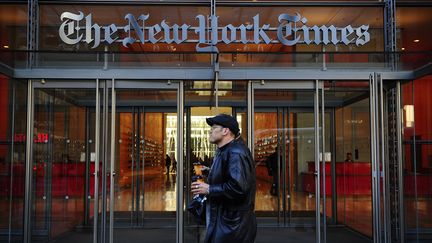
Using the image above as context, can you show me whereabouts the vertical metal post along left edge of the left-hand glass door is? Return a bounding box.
[109,79,116,243]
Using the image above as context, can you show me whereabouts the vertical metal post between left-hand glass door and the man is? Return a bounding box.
[176,81,184,243]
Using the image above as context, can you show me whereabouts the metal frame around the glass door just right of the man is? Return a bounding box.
[248,80,327,243]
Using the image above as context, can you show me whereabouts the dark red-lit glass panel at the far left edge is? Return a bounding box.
[0,74,27,242]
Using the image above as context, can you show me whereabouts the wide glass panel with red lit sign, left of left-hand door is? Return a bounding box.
[32,82,95,241]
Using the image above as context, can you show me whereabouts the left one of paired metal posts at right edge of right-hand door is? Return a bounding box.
[314,80,321,243]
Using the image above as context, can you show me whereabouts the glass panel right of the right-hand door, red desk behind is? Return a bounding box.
[326,81,372,237]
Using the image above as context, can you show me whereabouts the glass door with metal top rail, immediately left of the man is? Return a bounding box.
[112,81,179,242]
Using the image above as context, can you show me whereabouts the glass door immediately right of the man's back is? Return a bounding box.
[252,82,330,241]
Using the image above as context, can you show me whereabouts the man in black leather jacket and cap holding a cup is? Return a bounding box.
[191,114,256,243]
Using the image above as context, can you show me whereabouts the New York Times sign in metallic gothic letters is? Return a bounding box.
[59,11,370,52]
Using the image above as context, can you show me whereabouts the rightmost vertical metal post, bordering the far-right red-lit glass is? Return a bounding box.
[396,81,405,242]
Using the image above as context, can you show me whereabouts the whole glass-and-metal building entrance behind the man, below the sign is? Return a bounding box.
[26,80,378,242]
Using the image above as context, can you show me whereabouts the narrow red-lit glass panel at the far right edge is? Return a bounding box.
[401,75,432,241]
